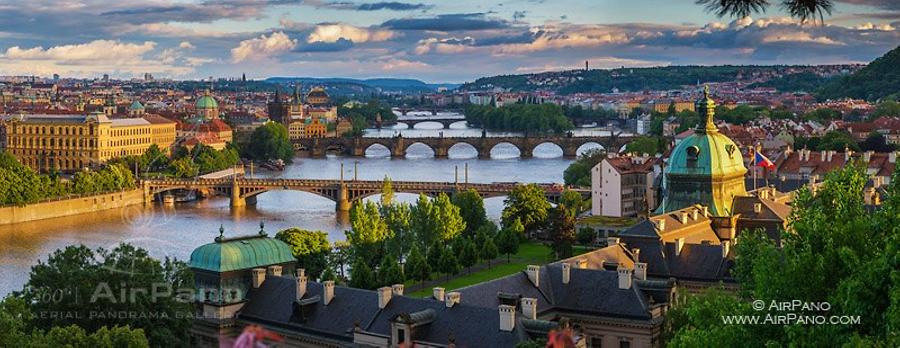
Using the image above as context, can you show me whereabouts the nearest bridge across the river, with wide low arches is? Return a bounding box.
[141,177,590,211]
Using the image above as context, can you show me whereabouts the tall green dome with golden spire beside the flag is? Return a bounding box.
[656,87,747,216]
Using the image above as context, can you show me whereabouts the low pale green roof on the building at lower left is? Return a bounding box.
[189,234,296,272]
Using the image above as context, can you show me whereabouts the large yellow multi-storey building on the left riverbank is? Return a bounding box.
[6,113,175,171]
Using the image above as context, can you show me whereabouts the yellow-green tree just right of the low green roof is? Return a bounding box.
[275,227,331,279]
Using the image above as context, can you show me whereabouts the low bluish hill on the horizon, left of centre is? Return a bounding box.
[266,77,458,95]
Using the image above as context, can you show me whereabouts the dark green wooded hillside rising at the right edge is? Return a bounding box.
[817,46,900,101]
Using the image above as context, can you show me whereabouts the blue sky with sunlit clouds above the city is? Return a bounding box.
[0,0,900,82]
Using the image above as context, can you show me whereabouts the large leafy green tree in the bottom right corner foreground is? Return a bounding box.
[667,163,900,347]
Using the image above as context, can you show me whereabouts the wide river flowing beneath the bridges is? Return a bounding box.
[0,123,602,297]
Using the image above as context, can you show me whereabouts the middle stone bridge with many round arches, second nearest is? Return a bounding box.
[294,133,633,158]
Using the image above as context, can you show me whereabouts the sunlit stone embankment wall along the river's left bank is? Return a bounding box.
[0,189,144,225]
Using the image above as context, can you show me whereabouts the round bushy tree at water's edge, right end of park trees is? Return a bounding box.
[500,184,550,235]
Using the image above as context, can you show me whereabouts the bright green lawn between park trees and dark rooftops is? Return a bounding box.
[406,242,588,297]
